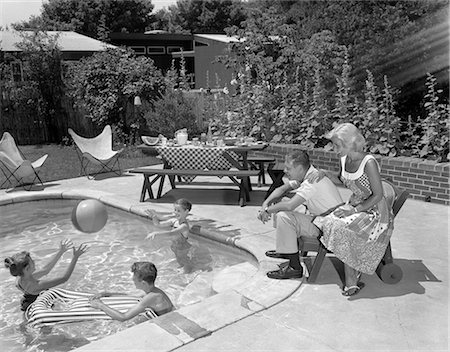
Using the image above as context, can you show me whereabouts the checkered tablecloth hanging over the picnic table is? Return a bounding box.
[156,145,238,182]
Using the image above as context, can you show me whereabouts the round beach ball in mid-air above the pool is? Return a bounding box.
[72,199,108,233]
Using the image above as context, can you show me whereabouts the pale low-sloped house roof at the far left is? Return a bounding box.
[0,31,116,52]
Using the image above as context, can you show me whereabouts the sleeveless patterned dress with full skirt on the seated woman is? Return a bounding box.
[320,155,393,274]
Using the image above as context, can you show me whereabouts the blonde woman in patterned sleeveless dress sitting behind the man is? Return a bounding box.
[317,123,393,296]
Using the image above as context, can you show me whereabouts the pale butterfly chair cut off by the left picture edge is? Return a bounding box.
[0,132,48,190]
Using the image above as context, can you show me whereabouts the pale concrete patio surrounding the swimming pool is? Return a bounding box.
[0,169,450,352]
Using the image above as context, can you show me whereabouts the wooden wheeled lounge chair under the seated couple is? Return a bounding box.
[298,180,409,284]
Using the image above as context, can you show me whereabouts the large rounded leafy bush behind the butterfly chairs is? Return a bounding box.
[67,49,164,137]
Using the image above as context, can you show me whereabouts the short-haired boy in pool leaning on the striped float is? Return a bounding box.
[89,262,174,321]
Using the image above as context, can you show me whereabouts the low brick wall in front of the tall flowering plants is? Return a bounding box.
[258,144,450,205]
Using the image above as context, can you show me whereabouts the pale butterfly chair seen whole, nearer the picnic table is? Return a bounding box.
[69,125,123,178]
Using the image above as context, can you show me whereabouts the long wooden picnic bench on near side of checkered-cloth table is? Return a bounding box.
[129,167,260,207]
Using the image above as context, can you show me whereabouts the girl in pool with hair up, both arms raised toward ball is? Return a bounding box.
[5,240,87,311]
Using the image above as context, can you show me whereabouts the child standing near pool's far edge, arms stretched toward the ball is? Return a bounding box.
[146,198,192,272]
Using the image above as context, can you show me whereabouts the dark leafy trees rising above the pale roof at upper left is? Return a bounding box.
[14,0,153,38]
